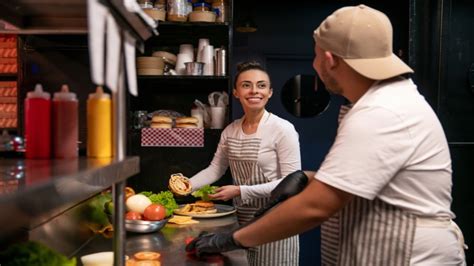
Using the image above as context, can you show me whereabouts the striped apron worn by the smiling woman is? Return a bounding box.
[227,137,299,266]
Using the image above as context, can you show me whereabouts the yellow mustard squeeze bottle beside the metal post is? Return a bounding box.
[87,86,112,158]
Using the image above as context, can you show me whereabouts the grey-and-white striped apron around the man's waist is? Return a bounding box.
[321,197,416,266]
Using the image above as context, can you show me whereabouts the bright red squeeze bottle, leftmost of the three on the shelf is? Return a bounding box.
[25,84,51,159]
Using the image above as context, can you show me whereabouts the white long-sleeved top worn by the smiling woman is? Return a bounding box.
[190,111,301,200]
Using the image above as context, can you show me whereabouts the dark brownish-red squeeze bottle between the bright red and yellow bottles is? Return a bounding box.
[52,85,79,159]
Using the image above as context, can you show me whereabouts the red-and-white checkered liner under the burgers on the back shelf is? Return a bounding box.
[141,128,204,147]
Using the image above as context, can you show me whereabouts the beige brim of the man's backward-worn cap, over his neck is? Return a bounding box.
[344,54,414,80]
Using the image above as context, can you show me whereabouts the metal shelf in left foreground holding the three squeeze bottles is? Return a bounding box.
[0,156,139,239]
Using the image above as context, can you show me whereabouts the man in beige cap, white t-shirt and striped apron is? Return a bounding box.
[187,5,465,265]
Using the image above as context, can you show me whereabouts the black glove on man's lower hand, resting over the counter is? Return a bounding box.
[186,231,245,257]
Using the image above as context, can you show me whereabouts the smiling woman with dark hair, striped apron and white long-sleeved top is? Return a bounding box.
[190,61,301,266]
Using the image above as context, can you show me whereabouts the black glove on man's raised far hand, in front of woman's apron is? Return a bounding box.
[254,170,308,217]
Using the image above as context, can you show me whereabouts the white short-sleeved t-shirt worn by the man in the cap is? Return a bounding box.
[315,78,454,218]
